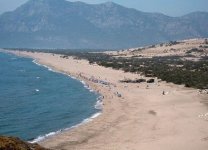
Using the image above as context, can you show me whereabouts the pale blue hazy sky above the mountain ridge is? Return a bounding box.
[0,0,208,16]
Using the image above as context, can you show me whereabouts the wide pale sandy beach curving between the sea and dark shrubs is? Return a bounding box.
[4,52,208,150]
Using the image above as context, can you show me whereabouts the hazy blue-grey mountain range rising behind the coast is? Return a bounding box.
[0,0,208,49]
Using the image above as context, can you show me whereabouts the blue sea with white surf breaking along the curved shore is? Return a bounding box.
[0,52,101,143]
